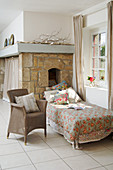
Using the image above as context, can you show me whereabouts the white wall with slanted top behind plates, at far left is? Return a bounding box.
[0,12,24,49]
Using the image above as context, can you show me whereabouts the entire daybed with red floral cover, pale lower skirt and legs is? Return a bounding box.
[46,81,113,149]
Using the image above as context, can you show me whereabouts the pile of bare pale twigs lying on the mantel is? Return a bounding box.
[33,31,70,45]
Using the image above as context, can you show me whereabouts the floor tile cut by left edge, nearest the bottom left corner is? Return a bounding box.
[0,153,31,169]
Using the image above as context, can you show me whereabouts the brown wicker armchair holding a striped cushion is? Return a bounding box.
[7,89,47,145]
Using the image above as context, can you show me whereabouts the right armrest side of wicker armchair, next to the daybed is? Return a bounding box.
[36,100,47,113]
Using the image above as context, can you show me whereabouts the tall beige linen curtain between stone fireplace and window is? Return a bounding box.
[73,15,85,100]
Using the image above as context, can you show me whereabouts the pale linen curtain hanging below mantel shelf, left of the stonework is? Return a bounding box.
[3,57,18,101]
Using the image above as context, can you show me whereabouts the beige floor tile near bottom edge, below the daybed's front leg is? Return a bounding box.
[64,155,100,170]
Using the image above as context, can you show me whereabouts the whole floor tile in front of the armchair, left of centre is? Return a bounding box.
[27,149,60,163]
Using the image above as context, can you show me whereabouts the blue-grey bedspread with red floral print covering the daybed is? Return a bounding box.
[47,102,113,142]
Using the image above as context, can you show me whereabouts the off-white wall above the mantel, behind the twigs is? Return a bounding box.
[24,12,73,43]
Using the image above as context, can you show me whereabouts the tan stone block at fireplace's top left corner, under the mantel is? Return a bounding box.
[22,53,33,67]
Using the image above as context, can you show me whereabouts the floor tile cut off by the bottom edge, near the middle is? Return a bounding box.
[35,160,71,170]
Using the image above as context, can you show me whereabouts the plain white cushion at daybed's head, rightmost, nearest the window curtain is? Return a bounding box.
[66,87,82,103]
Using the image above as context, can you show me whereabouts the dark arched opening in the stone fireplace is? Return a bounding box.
[48,68,60,87]
